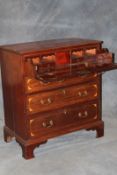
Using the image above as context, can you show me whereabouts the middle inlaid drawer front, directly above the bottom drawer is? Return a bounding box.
[26,82,98,114]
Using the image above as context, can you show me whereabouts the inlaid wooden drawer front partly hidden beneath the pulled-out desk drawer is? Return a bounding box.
[25,74,97,94]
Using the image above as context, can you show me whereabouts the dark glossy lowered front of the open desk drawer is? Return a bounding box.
[31,52,117,82]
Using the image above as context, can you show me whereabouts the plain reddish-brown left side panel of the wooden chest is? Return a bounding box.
[1,50,26,137]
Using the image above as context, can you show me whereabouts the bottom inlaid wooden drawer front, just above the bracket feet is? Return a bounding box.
[29,102,98,137]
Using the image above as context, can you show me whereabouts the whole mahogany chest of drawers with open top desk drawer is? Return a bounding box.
[0,38,117,159]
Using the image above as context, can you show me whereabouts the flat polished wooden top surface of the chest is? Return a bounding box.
[1,38,102,54]
